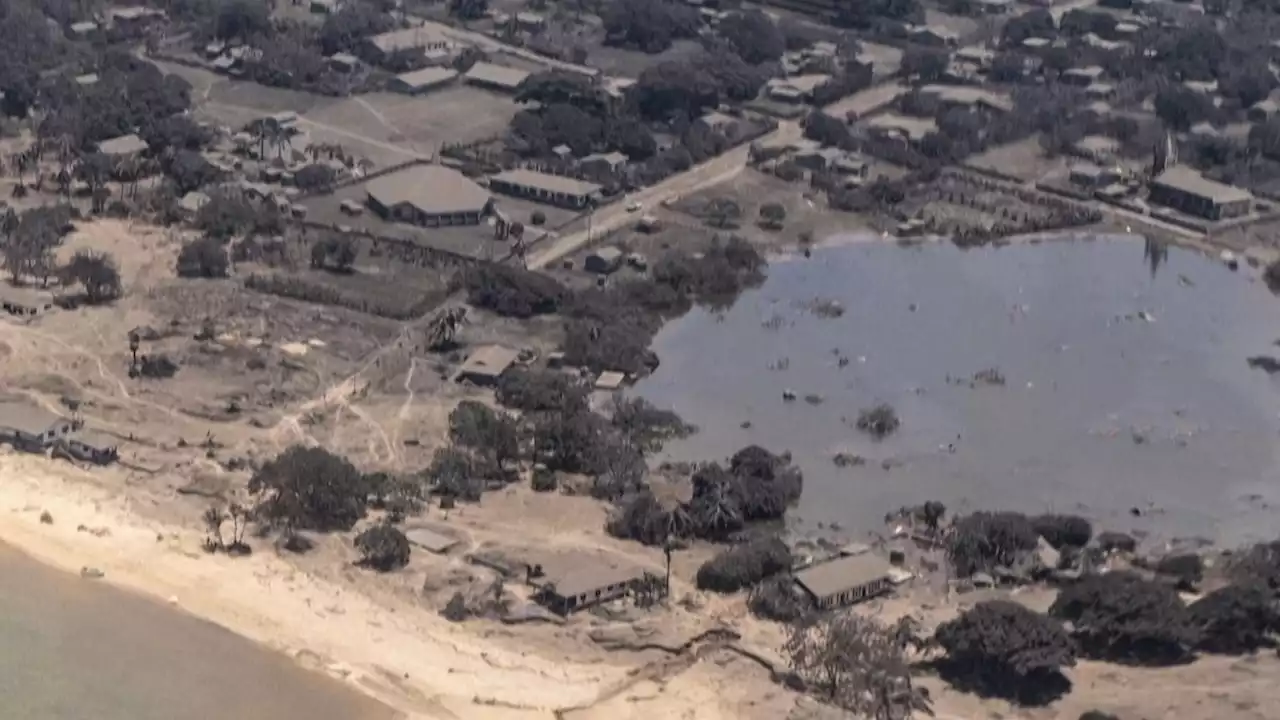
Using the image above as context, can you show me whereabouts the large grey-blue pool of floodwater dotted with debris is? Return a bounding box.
[636,238,1280,543]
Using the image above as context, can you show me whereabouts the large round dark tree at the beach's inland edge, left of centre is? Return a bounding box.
[248,445,369,532]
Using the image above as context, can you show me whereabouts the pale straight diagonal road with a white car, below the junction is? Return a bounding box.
[529,120,803,269]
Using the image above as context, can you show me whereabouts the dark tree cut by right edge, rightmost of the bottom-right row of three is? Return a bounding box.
[1188,583,1280,655]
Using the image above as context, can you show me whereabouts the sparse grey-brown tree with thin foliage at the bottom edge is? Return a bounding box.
[782,612,932,720]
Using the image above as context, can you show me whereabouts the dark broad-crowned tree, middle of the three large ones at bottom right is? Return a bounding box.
[1050,573,1197,665]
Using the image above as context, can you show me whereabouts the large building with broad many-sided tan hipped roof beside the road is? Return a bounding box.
[365,165,493,228]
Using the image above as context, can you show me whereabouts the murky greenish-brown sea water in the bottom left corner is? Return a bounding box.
[0,547,393,720]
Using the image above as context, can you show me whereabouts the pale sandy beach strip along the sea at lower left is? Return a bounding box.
[0,451,621,720]
